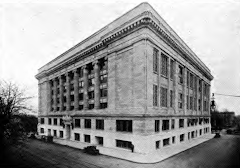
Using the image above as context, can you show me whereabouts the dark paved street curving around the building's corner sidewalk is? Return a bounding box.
[0,135,240,168]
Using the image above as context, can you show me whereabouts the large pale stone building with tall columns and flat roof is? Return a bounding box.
[36,3,213,163]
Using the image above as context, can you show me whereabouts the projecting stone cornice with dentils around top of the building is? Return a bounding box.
[36,11,213,80]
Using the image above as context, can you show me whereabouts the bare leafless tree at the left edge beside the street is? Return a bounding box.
[0,81,31,160]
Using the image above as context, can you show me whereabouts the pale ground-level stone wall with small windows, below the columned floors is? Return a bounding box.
[38,116,211,161]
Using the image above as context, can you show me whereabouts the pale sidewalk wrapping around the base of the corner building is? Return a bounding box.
[54,134,214,163]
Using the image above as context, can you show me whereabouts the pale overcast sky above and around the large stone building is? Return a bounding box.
[0,0,240,115]
